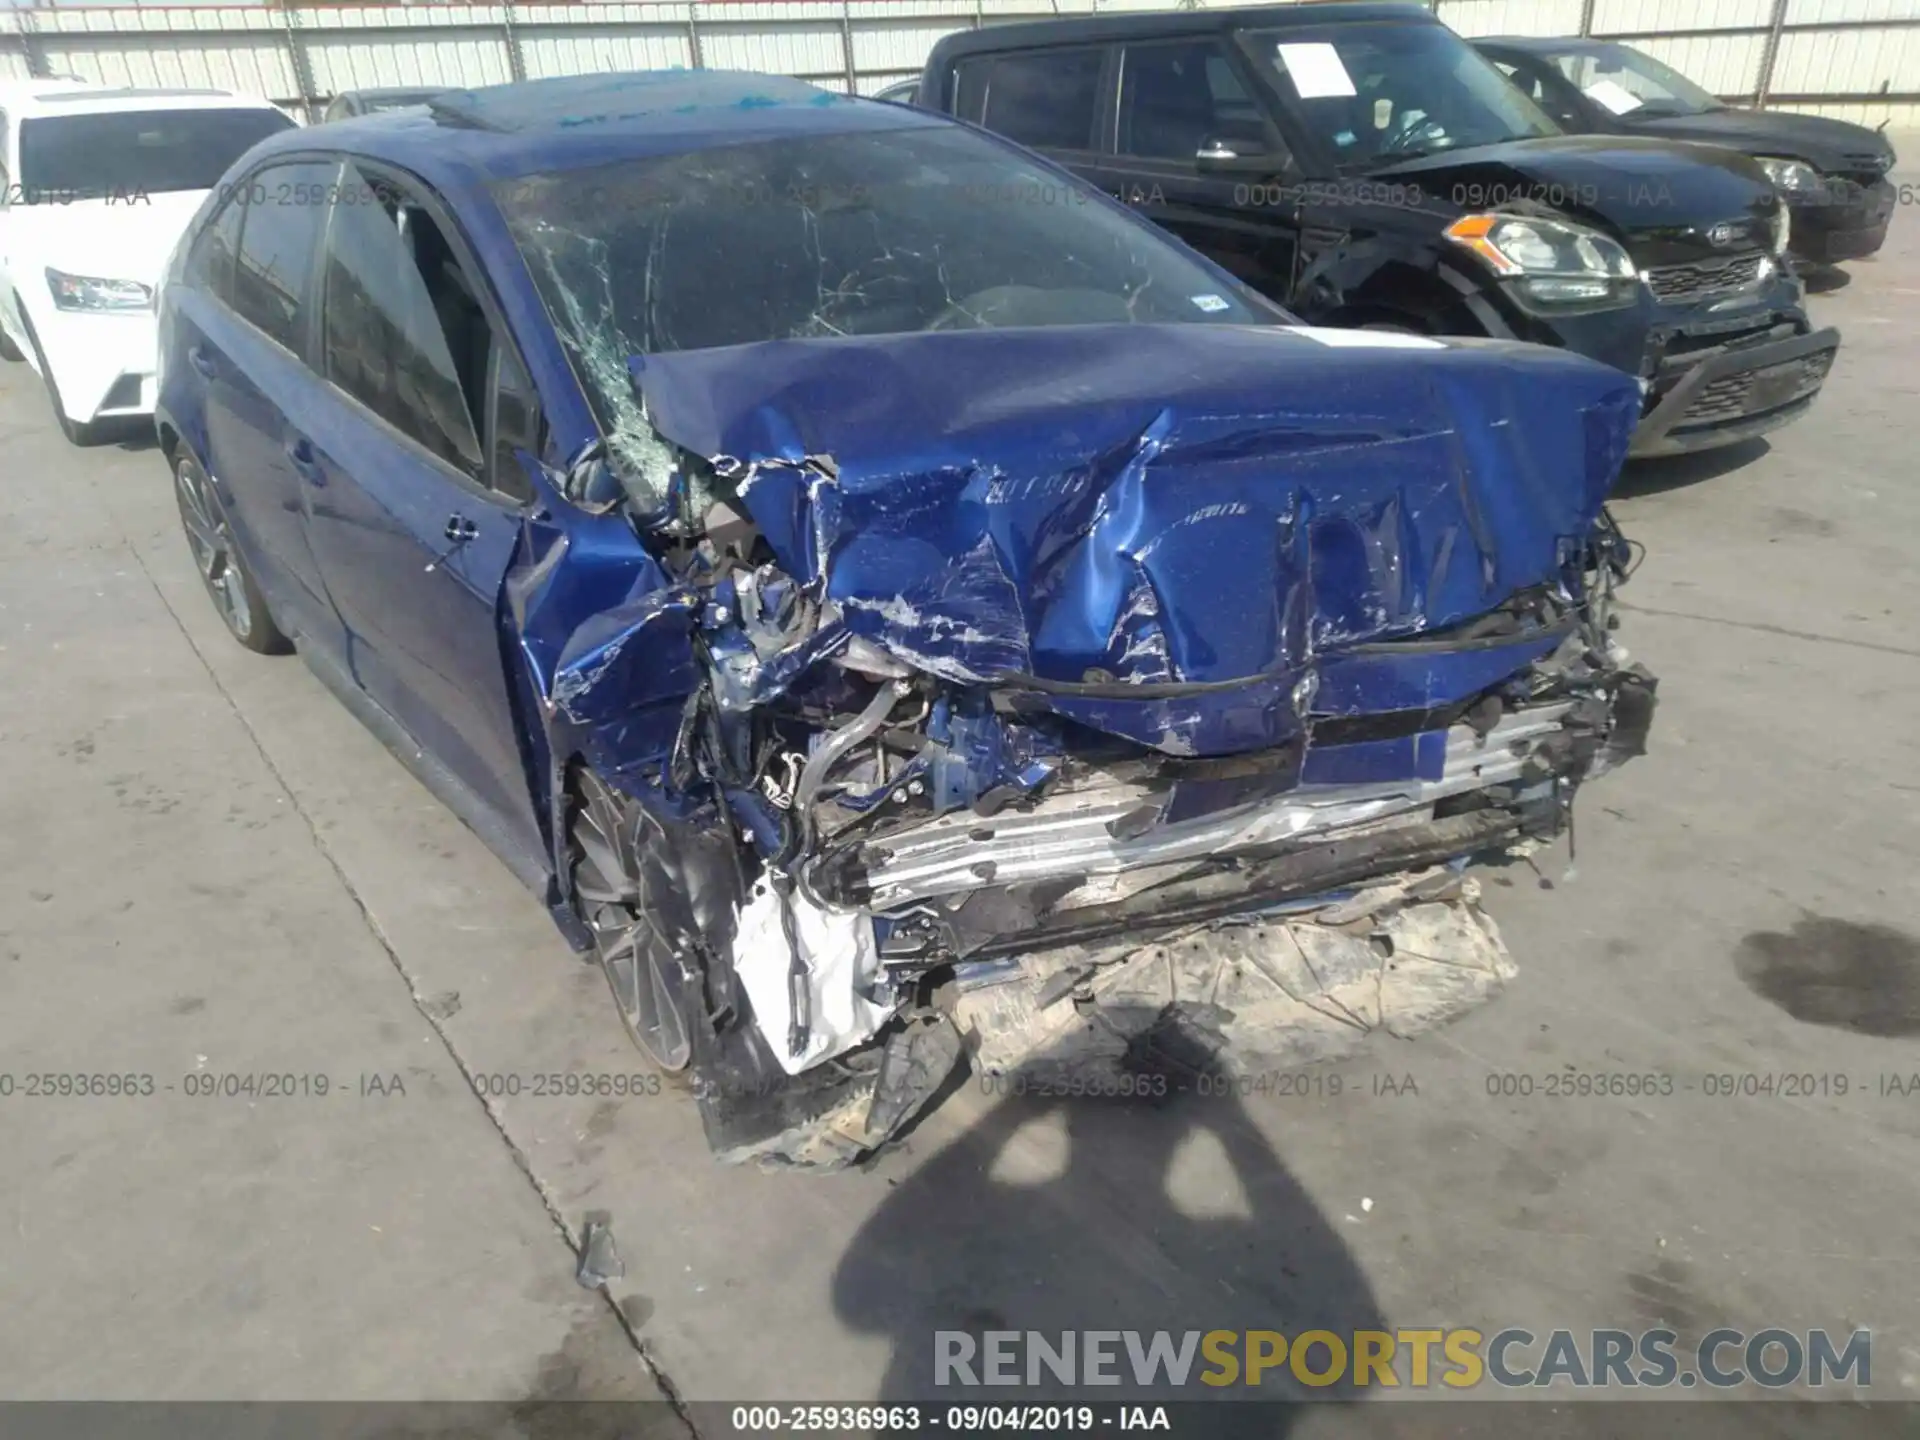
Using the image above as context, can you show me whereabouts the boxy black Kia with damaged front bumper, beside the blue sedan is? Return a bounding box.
[918,4,1839,455]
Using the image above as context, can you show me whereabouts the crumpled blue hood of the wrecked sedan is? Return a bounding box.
[636,324,1640,710]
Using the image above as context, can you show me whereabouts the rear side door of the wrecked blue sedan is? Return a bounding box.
[195,159,340,649]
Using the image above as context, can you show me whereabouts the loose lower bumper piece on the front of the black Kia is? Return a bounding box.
[1632,326,1839,457]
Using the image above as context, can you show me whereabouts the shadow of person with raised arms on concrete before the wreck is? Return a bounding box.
[833,1052,1386,1436]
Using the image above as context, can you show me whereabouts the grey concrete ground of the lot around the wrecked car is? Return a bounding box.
[0,183,1920,1434]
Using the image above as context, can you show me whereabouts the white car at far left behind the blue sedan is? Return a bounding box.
[0,81,294,445]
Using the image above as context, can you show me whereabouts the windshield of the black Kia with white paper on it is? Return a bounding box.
[1248,23,1561,169]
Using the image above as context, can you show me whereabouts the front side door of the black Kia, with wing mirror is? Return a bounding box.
[1108,36,1298,303]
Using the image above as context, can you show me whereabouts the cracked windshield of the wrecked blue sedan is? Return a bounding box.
[497,127,1283,480]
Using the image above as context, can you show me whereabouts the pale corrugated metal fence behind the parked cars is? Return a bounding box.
[0,0,1920,129]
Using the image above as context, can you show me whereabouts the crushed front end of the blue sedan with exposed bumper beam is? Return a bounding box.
[509,324,1655,1165]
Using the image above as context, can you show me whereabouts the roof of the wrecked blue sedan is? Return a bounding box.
[250,69,952,194]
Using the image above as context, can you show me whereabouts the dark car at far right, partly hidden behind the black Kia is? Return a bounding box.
[1473,38,1895,265]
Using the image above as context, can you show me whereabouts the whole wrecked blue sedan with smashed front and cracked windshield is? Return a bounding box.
[159,73,1653,1165]
